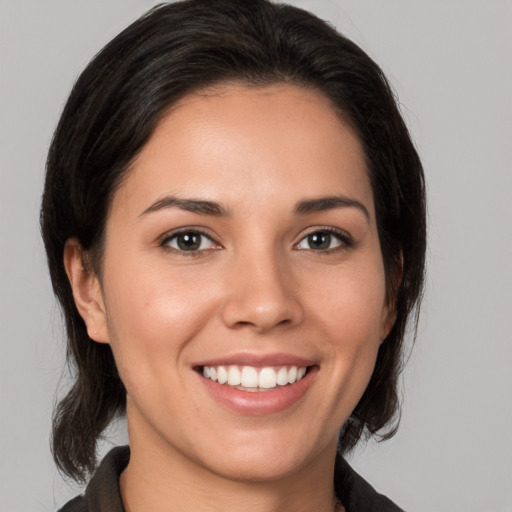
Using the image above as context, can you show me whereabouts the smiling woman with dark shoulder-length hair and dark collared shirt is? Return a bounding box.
[41,0,425,512]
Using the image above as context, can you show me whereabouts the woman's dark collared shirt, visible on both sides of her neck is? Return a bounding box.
[59,446,404,512]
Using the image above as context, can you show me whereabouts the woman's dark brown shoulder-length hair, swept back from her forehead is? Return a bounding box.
[41,0,426,479]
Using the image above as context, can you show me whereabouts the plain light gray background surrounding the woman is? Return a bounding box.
[0,0,512,512]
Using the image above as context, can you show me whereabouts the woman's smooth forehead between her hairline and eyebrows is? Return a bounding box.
[114,84,373,218]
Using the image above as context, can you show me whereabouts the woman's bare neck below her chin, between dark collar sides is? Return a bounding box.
[120,412,343,512]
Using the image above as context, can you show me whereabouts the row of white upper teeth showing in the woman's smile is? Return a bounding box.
[203,365,307,391]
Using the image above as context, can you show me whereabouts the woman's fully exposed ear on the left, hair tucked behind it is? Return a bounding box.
[64,238,110,343]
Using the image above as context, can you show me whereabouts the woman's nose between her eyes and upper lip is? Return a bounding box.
[222,247,304,333]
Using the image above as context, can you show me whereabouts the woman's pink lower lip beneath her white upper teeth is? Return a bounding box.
[198,366,318,416]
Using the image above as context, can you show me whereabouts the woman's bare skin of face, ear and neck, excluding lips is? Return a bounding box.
[65,84,394,512]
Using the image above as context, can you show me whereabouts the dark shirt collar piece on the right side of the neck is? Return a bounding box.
[334,456,404,512]
